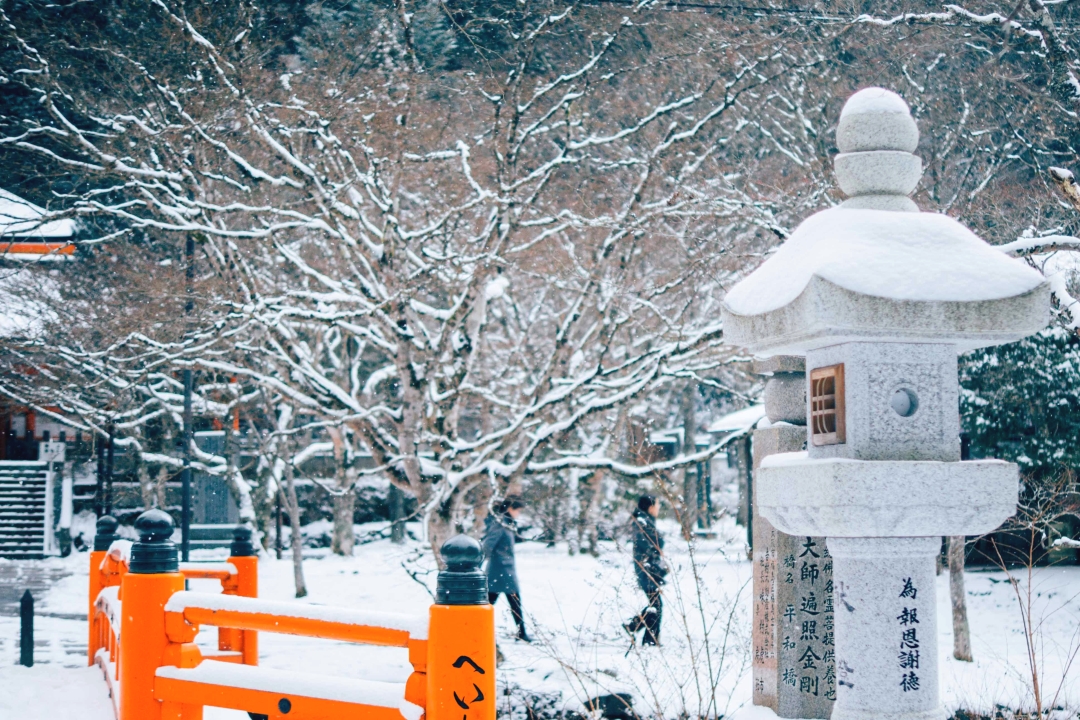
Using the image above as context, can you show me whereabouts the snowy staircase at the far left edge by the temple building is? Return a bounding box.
[0,461,52,560]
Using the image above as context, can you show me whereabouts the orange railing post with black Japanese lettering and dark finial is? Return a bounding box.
[424,535,495,720]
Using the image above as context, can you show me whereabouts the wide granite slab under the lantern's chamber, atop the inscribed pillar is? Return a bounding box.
[755,452,1020,538]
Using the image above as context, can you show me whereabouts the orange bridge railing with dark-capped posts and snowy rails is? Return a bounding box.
[90,510,495,720]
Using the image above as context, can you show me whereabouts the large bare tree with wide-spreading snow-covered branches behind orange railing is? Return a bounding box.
[0,0,842,546]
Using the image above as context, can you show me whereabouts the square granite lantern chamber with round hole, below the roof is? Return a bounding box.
[804,342,960,462]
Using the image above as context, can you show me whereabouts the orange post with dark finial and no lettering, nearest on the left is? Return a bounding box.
[118,510,186,720]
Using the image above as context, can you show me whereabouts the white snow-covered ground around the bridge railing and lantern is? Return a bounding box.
[0,525,1080,720]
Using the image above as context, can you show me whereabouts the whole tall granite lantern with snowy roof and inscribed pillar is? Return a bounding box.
[724,87,1050,720]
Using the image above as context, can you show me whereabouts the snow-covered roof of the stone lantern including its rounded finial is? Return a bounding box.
[724,87,1050,356]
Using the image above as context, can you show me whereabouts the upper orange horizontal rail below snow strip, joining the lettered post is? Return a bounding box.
[165,608,409,648]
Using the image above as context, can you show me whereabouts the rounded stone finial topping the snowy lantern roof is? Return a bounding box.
[834,87,922,212]
